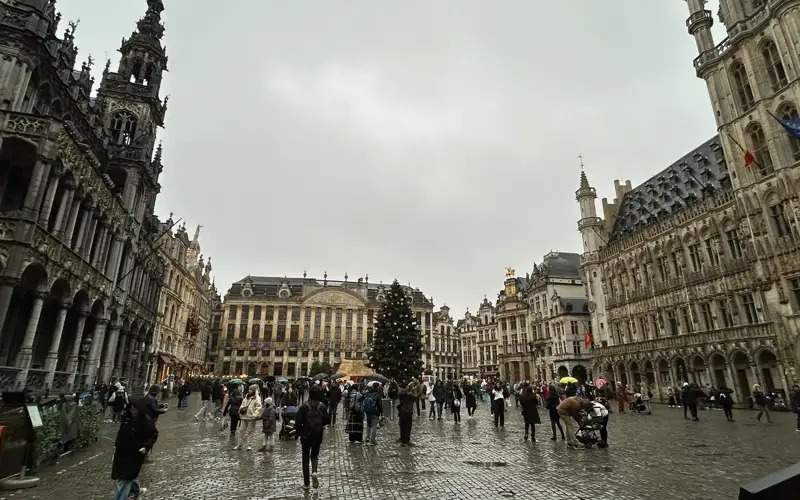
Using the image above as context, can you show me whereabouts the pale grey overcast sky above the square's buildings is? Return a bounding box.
[58,0,720,317]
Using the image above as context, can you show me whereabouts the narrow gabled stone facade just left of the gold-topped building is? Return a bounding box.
[456,297,498,379]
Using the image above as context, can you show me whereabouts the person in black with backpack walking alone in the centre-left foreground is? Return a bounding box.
[295,386,331,490]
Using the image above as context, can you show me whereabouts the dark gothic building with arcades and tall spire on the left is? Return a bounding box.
[0,0,167,392]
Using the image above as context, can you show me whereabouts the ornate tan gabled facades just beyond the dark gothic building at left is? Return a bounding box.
[150,223,216,382]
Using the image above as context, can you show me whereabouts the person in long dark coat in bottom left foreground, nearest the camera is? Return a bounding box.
[111,398,158,499]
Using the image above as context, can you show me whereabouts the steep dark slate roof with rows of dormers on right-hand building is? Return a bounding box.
[609,135,731,241]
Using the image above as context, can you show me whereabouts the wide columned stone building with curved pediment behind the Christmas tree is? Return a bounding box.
[212,274,433,378]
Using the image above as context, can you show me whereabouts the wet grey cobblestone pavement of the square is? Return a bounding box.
[0,400,800,500]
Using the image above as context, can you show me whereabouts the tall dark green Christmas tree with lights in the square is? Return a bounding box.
[369,280,422,383]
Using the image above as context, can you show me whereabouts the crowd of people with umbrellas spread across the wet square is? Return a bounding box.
[97,377,800,500]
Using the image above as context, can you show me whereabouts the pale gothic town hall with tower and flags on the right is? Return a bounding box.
[576,0,800,402]
